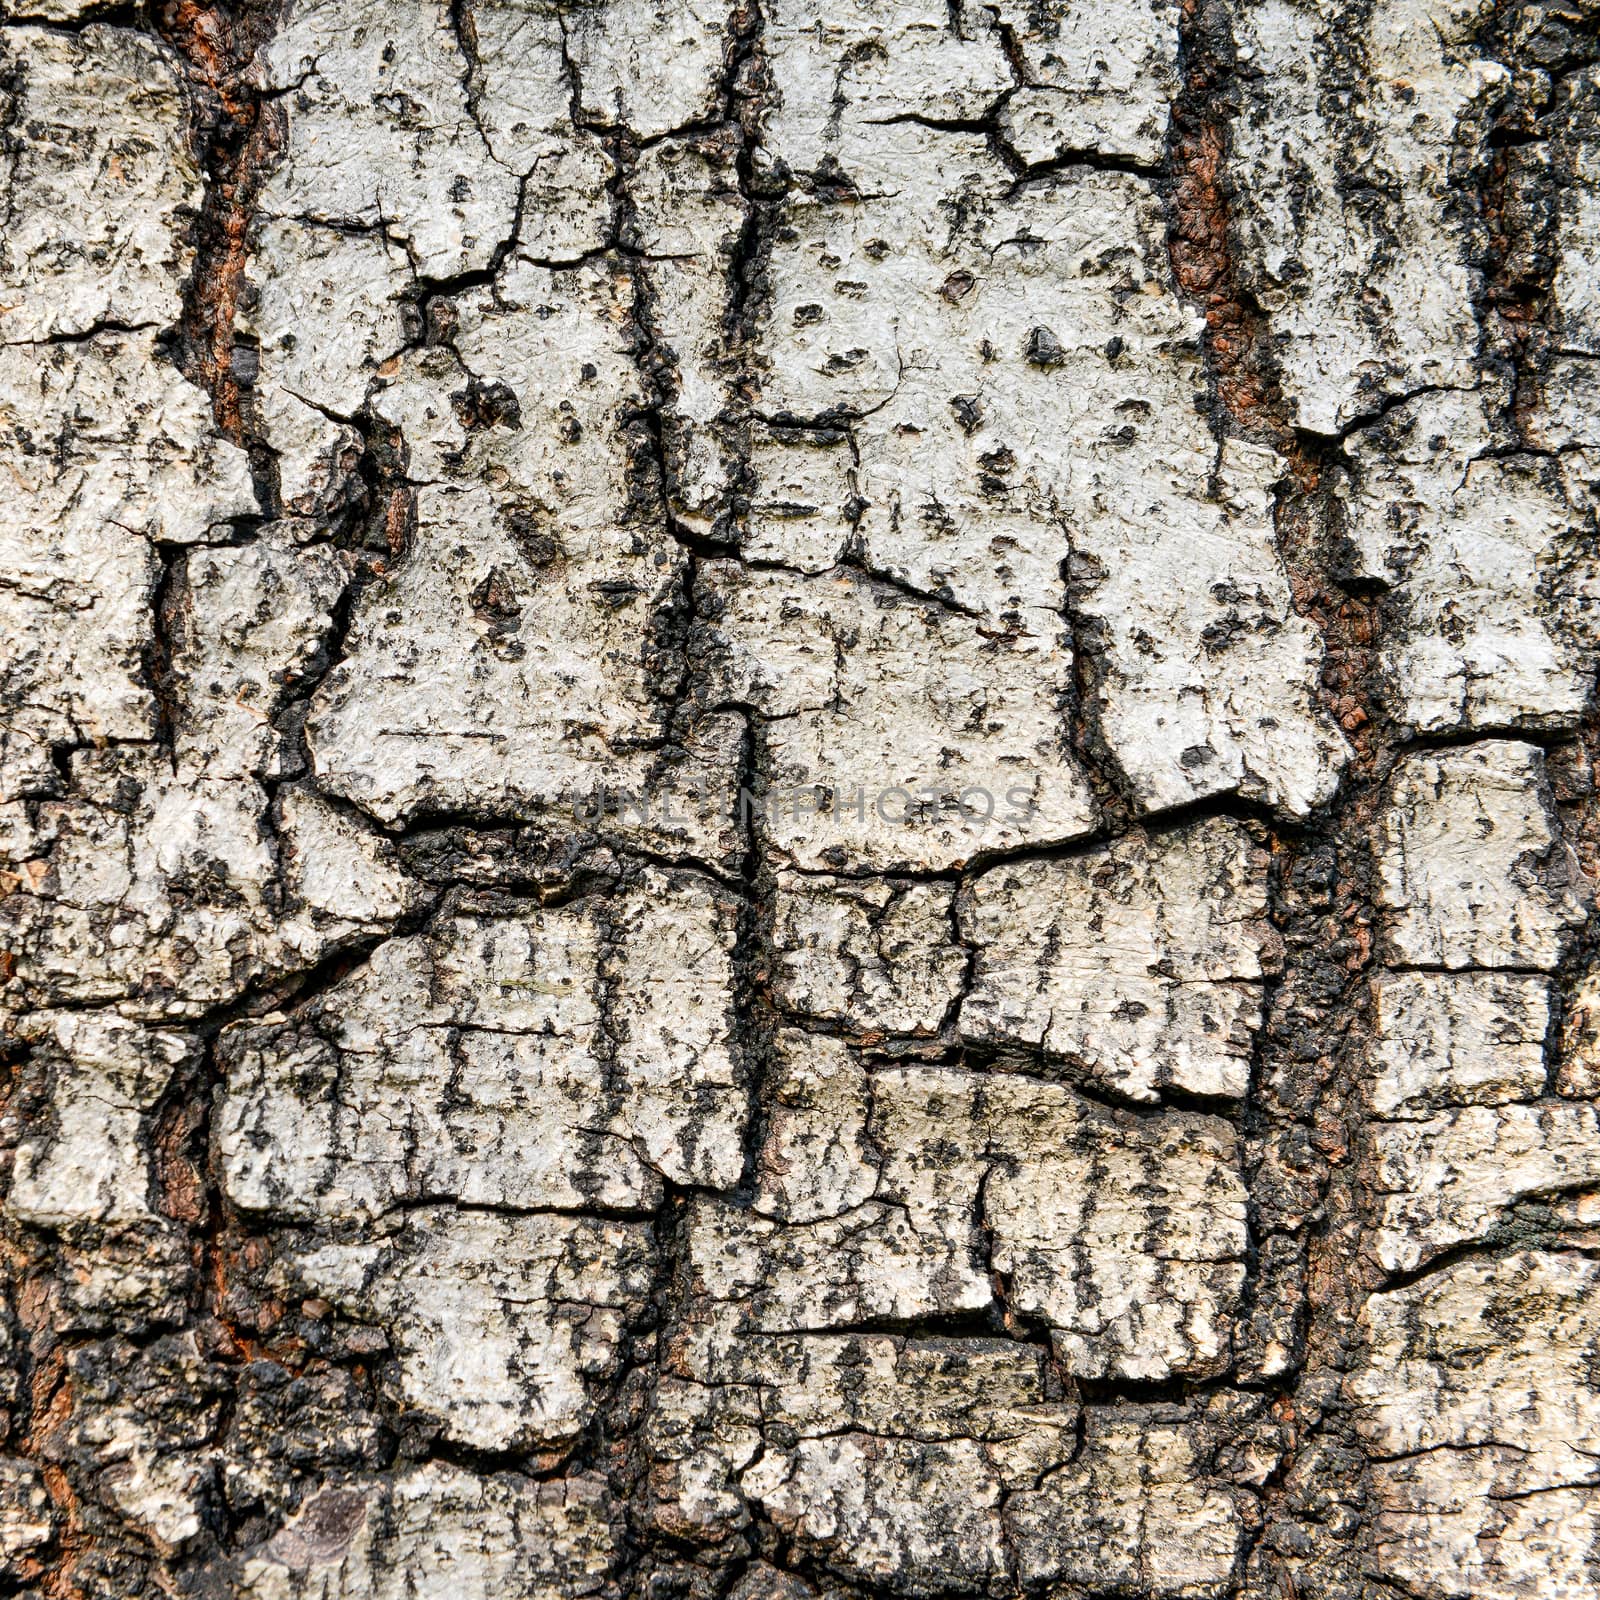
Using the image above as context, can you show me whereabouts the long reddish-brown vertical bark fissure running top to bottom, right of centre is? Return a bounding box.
[1168,0,1394,1594]
